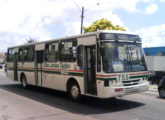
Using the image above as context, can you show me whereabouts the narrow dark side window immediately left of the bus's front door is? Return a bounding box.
[77,45,83,67]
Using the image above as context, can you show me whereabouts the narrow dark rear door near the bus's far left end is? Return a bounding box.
[14,53,18,81]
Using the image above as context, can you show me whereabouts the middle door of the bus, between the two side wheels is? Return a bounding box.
[35,50,44,86]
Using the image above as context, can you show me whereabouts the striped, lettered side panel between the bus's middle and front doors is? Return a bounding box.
[43,62,84,93]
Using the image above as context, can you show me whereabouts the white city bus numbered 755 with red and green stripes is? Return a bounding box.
[7,31,149,100]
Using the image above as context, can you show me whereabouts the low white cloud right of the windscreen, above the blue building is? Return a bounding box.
[136,24,165,47]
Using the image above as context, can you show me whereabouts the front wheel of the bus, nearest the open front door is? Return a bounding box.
[68,82,81,101]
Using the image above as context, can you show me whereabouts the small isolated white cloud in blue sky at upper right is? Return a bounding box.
[145,4,158,14]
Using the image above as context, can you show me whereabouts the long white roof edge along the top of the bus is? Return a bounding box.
[9,30,137,49]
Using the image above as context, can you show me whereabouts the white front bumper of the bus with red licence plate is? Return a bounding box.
[102,82,149,98]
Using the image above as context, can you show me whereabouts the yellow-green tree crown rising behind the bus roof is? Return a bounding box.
[83,18,125,33]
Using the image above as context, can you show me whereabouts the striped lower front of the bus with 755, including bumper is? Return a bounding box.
[97,71,149,98]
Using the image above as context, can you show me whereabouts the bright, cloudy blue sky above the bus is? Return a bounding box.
[0,0,165,52]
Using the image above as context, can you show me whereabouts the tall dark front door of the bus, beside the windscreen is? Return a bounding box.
[84,45,97,95]
